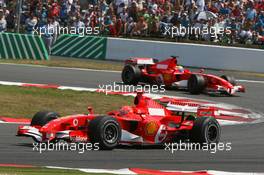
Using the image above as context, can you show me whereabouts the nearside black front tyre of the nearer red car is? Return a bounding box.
[88,116,121,150]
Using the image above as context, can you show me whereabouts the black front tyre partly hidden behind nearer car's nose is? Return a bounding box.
[30,111,60,126]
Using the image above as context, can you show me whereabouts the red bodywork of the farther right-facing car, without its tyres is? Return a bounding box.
[125,57,245,95]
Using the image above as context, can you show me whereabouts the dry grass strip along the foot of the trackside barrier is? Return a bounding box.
[0,56,264,78]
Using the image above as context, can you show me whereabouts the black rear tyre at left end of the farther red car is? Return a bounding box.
[122,65,141,85]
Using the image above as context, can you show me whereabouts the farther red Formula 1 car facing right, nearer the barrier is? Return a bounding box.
[122,56,245,95]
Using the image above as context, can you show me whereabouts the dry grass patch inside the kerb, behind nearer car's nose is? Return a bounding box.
[0,85,133,118]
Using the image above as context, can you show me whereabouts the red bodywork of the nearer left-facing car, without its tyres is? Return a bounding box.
[17,93,219,144]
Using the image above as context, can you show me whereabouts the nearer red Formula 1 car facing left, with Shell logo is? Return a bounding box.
[17,93,221,149]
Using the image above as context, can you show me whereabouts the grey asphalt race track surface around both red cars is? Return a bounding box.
[0,64,264,172]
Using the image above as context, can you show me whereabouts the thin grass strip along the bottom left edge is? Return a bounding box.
[0,167,112,175]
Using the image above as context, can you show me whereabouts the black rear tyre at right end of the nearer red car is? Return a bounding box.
[190,117,221,145]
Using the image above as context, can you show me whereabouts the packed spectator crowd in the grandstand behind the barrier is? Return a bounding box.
[0,0,264,44]
